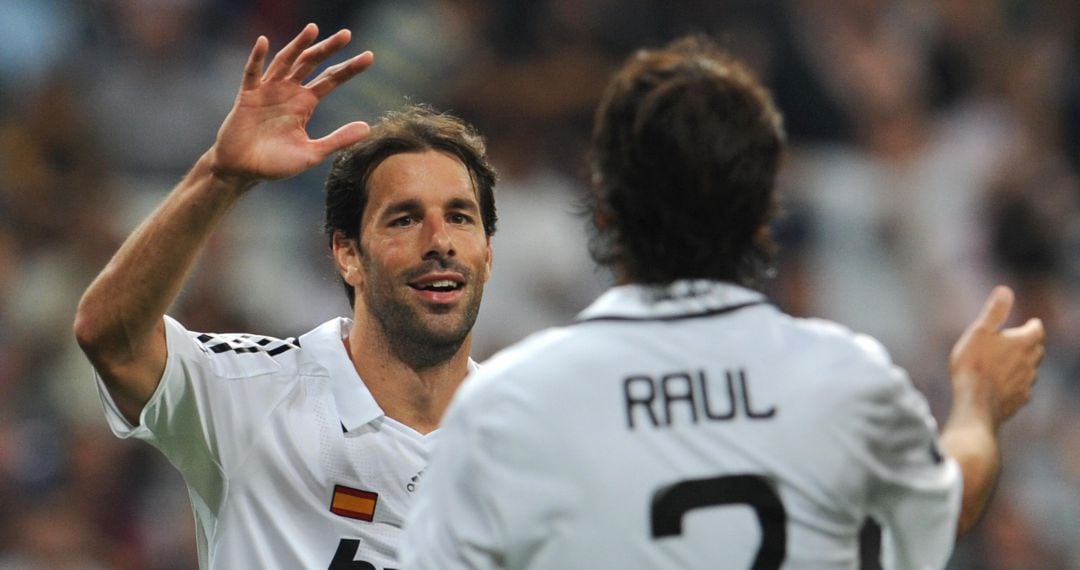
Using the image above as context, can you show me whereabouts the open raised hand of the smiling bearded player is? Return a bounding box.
[210,24,374,186]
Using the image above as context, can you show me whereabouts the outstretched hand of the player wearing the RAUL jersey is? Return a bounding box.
[950,286,1045,428]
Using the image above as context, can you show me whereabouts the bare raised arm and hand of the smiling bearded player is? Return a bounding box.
[75,24,373,423]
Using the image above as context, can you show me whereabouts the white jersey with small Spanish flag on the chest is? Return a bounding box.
[98,317,475,570]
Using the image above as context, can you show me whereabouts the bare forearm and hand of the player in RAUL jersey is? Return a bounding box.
[942,287,1044,535]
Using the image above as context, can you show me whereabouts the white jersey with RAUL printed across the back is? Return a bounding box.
[402,282,961,570]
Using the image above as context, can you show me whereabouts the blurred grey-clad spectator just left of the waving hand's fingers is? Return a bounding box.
[76,0,252,182]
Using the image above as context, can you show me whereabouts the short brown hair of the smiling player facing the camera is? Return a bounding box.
[324,105,498,306]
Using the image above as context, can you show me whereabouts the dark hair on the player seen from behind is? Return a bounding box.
[588,36,785,285]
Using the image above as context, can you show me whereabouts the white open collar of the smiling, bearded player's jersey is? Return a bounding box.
[300,317,478,432]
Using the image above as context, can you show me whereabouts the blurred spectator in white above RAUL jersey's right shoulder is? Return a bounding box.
[777,1,1011,401]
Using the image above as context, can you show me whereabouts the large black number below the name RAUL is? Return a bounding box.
[649,475,787,570]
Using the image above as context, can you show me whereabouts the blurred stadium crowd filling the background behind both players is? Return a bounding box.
[0,0,1080,570]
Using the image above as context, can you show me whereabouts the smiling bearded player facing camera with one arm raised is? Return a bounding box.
[75,25,496,570]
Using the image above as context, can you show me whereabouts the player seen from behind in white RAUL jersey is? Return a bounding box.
[402,38,1043,570]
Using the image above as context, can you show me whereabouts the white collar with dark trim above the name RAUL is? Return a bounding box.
[576,280,767,323]
